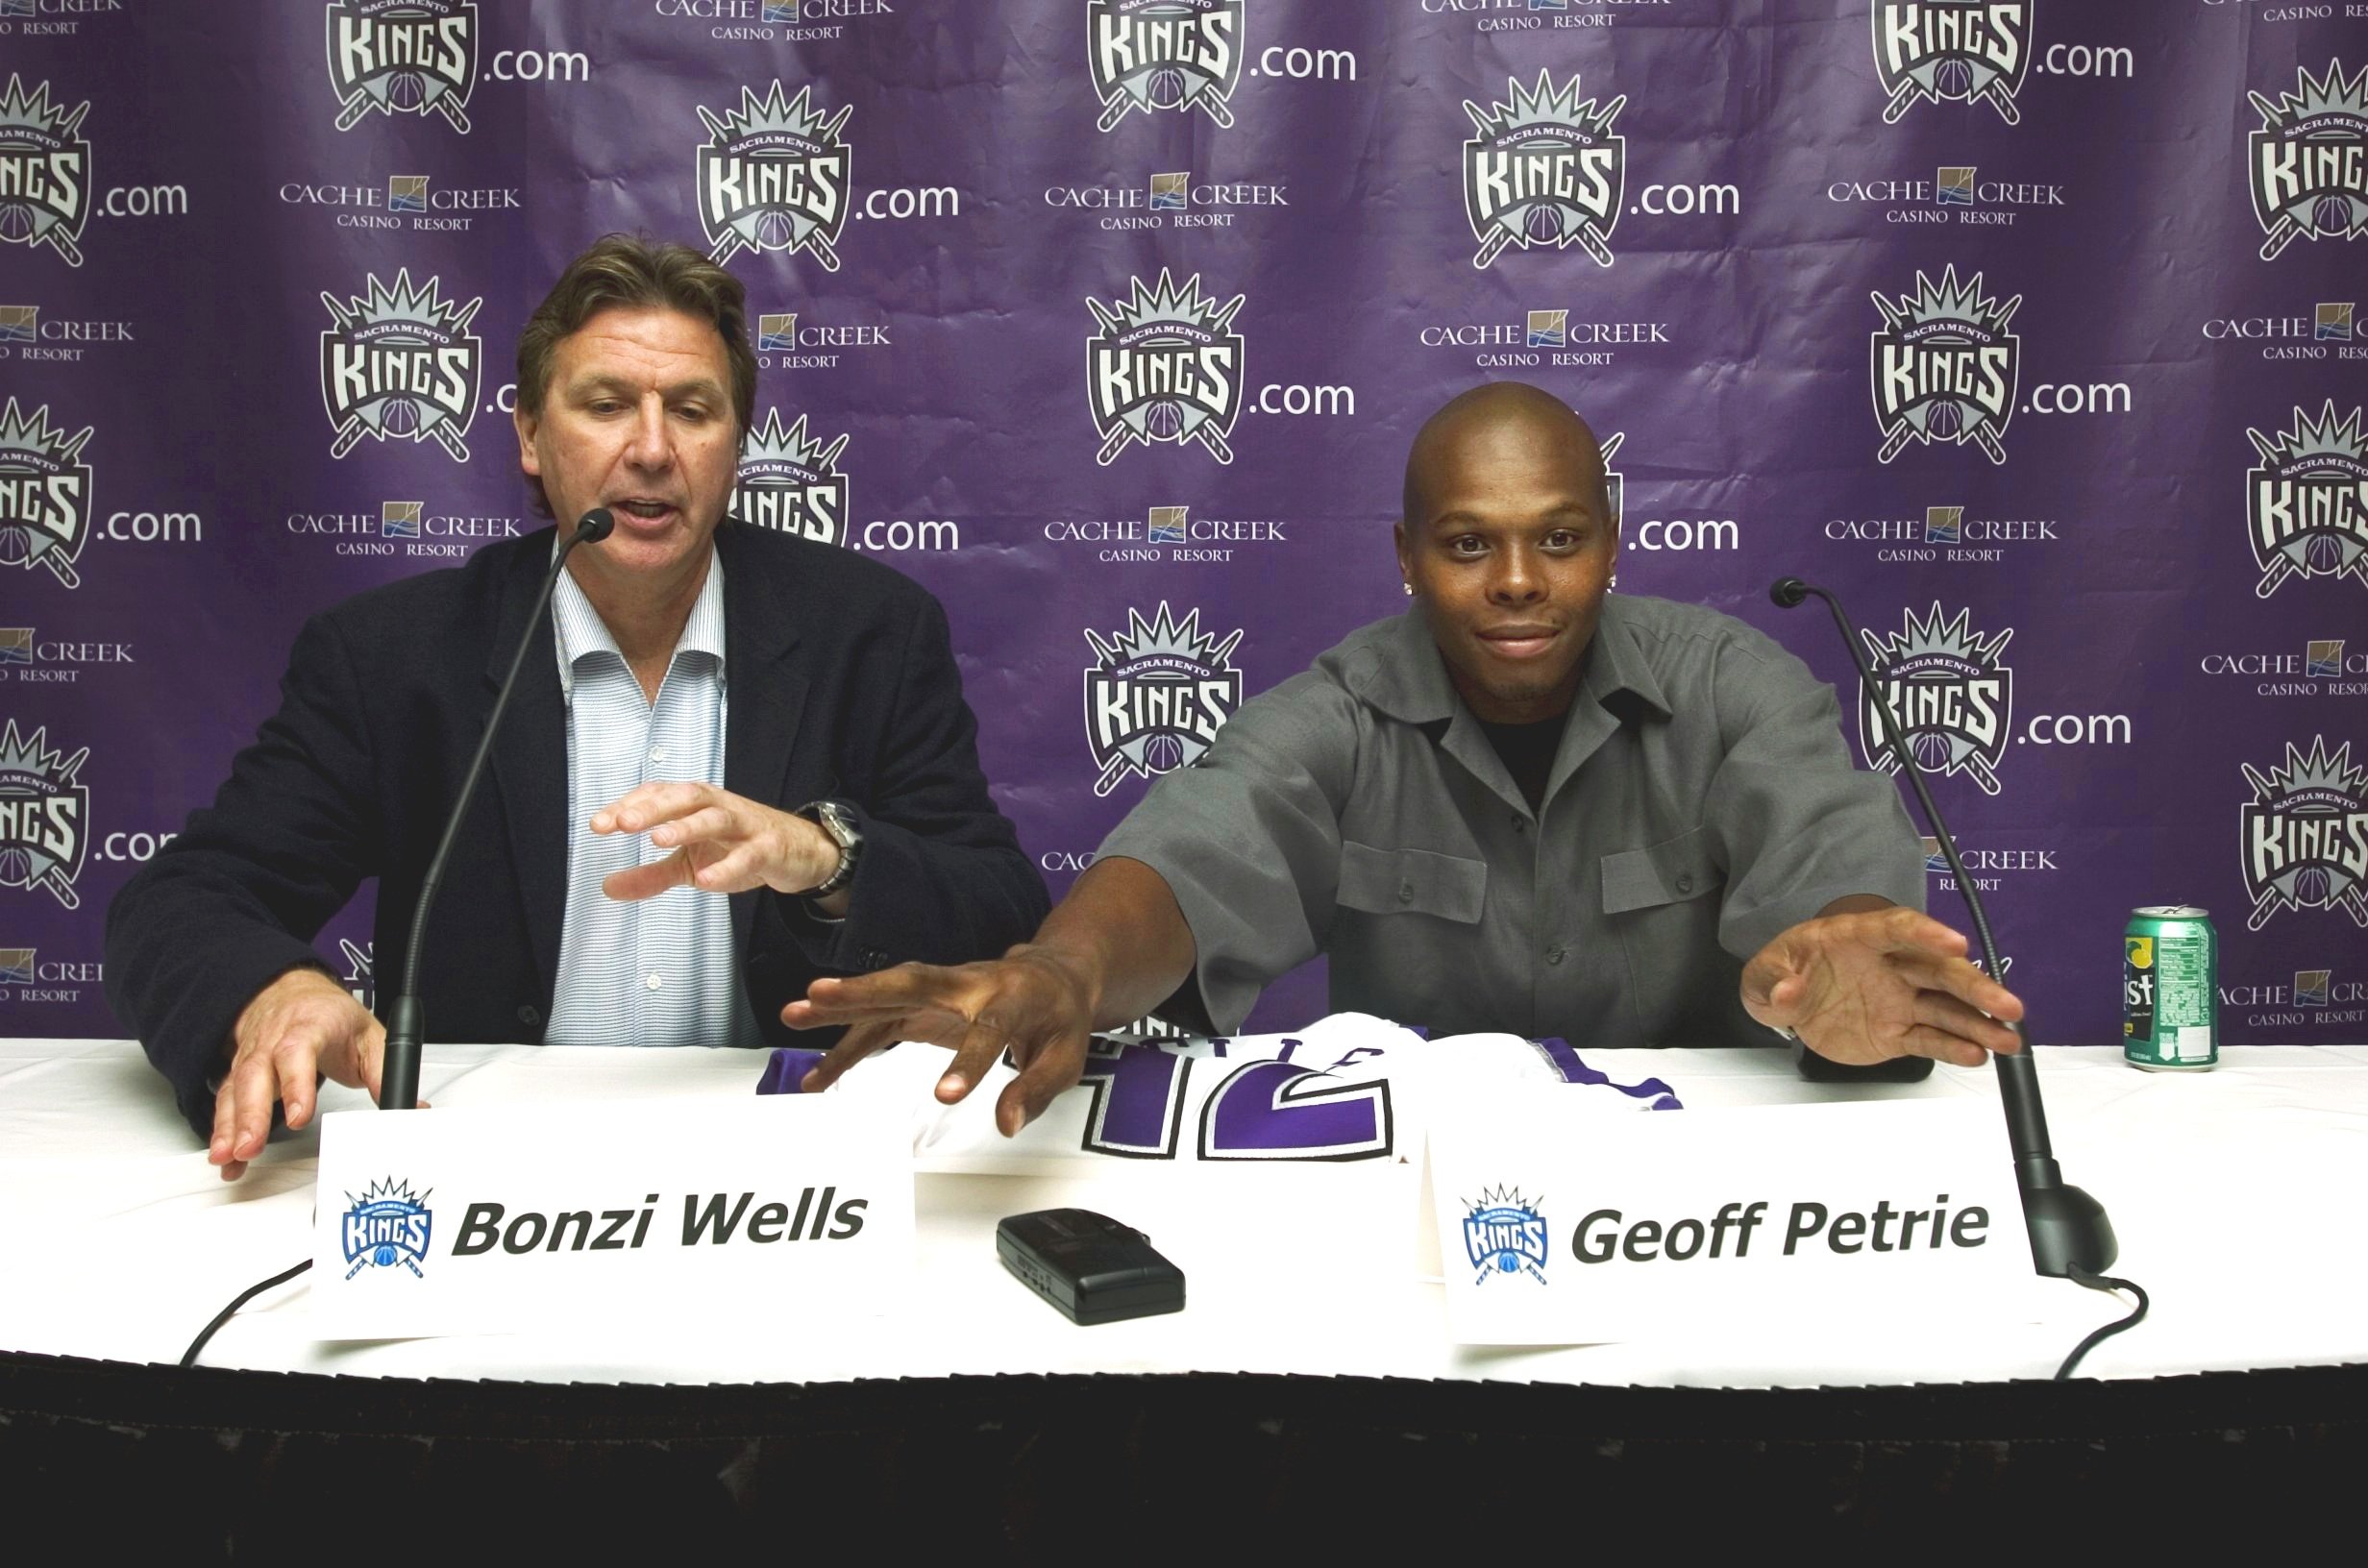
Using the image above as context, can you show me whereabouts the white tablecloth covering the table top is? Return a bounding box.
[0,1040,2368,1385]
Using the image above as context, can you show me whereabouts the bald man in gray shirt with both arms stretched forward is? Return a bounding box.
[781,381,2022,1132]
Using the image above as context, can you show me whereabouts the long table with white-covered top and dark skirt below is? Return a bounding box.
[0,1040,2368,1556]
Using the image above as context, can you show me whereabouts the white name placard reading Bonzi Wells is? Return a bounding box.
[310,1094,914,1338]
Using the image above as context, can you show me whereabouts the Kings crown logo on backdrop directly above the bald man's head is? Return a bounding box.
[1464,71,1627,268]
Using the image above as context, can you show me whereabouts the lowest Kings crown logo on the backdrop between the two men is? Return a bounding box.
[1085,600,1241,796]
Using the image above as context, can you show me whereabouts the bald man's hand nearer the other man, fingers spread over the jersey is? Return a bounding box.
[781,945,1098,1137]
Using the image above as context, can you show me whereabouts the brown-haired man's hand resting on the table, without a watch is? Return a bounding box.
[206,968,386,1182]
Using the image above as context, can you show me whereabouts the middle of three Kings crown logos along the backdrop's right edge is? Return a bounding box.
[2245,398,2368,600]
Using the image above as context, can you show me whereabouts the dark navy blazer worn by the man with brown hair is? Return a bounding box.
[107,521,1047,1137]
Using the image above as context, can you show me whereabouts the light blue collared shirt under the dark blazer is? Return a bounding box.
[542,547,757,1044]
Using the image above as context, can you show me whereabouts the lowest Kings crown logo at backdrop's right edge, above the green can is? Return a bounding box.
[2237,734,2368,931]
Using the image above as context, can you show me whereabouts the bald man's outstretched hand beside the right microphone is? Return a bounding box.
[1743,907,2022,1068]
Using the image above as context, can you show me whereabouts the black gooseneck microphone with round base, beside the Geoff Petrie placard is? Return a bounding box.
[1769,578,2119,1277]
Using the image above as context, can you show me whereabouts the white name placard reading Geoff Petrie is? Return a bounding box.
[1430,1090,2039,1345]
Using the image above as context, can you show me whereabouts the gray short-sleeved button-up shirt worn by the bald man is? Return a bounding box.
[1101,595,1925,1047]
